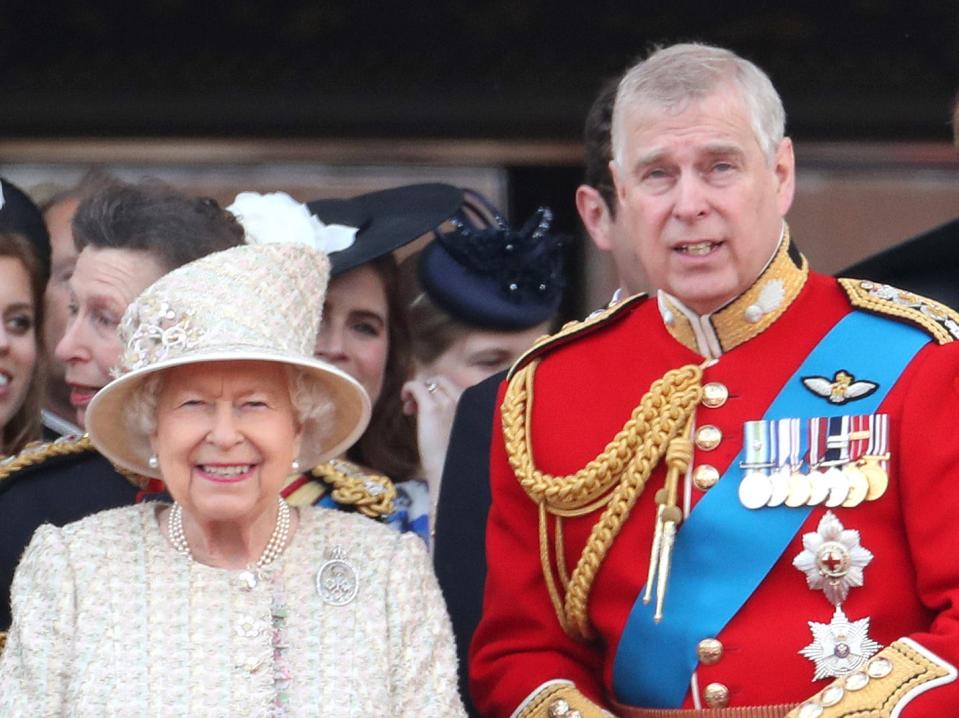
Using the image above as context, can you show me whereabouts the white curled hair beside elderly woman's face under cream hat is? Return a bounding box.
[123,364,335,458]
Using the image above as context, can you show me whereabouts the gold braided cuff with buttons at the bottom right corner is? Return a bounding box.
[787,640,955,718]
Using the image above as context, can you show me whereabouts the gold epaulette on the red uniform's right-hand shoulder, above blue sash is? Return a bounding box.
[839,279,959,344]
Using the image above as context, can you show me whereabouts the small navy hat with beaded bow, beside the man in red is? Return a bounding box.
[419,190,566,330]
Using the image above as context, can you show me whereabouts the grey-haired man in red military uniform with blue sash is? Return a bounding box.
[470,40,959,718]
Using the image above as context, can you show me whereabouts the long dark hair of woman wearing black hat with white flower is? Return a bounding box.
[346,254,420,481]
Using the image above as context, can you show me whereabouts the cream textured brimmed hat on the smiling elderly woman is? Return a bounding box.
[86,244,370,477]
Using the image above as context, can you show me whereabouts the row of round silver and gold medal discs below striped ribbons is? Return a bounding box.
[739,454,889,509]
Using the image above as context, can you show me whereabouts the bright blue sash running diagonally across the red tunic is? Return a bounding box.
[613,311,929,708]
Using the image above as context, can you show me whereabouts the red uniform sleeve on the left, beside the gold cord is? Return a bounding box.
[470,387,603,717]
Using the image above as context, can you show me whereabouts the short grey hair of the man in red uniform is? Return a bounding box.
[612,43,786,167]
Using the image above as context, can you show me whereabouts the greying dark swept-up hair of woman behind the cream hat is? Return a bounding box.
[73,180,244,271]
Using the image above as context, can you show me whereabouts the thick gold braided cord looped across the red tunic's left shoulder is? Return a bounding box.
[502,359,703,639]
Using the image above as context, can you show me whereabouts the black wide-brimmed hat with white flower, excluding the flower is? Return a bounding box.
[306,182,463,277]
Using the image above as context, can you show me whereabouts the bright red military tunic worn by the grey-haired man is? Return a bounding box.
[470,239,959,718]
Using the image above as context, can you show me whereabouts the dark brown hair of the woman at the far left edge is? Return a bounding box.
[0,232,46,455]
